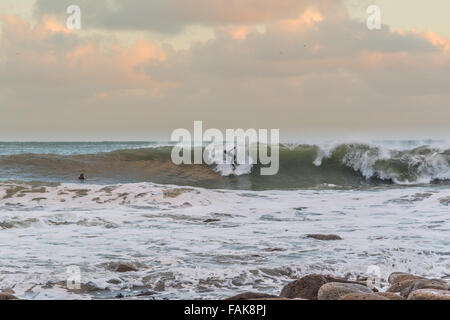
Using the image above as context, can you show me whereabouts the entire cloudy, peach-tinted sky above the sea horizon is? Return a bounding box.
[0,0,450,141]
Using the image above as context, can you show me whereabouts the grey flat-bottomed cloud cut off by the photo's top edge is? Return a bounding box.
[35,0,341,33]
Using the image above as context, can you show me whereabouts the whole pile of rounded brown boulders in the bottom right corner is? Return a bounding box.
[225,272,450,300]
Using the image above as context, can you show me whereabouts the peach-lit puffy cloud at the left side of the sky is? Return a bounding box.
[0,15,171,98]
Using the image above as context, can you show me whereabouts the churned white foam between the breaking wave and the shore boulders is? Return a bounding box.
[0,183,450,299]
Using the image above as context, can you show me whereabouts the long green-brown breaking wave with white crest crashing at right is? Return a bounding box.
[0,143,450,190]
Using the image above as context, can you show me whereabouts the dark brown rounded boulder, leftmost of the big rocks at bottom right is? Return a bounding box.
[280,274,368,300]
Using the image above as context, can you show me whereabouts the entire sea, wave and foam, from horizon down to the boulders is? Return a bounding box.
[0,140,450,299]
